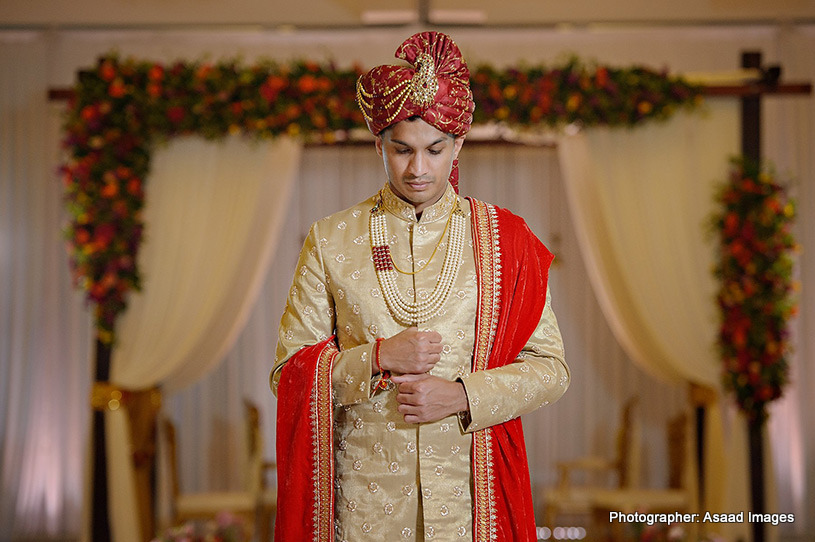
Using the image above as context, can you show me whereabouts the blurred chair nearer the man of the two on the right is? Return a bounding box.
[543,396,640,527]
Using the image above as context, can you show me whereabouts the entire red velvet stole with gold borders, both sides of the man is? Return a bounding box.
[275,198,554,542]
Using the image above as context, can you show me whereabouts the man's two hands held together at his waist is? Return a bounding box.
[373,327,469,423]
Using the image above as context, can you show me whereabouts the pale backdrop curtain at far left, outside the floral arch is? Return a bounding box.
[0,32,91,540]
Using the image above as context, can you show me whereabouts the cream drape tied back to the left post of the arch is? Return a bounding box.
[105,137,300,542]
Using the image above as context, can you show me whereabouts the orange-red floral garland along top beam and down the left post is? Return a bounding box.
[61,55,701,344]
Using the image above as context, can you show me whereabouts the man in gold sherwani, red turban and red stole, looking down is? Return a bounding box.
[271,32,569,542]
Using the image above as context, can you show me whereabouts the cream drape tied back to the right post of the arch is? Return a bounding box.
[558,99,760,538]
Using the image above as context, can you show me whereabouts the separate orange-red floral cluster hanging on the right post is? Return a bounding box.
[712,160,798,425]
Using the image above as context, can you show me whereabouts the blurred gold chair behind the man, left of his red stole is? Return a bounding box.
[162,400,277,542]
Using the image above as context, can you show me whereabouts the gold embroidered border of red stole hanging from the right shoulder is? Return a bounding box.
[470,198,501,542]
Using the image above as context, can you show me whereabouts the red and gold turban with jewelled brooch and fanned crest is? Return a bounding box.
[357,32,475,136]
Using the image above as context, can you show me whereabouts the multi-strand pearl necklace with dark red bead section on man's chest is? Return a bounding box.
[368,195,467,325]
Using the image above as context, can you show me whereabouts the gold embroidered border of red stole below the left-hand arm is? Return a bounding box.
[311,341,339,542]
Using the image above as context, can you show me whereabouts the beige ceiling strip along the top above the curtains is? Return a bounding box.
[0,0,815,29]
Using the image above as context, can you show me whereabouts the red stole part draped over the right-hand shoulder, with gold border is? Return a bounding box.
[470,198,554,542]
